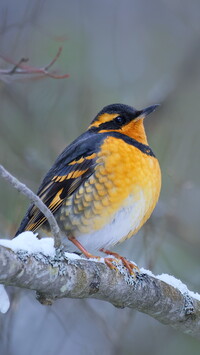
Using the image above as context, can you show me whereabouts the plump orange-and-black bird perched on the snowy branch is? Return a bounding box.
[15,103,161,273]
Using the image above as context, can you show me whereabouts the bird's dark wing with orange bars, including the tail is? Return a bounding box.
[16,135,103,236]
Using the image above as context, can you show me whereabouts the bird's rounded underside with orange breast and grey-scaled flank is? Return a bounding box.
[60,136,161,247]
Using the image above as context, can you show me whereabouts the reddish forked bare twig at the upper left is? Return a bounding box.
[0,47,69,82]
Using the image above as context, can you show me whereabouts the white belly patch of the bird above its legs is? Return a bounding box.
[65,191,145,252]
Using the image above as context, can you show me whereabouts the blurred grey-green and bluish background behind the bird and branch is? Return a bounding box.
[0,0,200,355]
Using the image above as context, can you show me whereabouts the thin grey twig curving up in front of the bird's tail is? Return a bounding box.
[0,165,61,248]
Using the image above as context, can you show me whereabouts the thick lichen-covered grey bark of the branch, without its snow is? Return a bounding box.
[0,246,200,339]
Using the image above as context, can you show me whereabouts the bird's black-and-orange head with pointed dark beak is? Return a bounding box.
[89,104,159,144]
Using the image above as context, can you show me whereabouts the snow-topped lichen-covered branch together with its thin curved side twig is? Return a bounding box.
[0,165,200,339]
